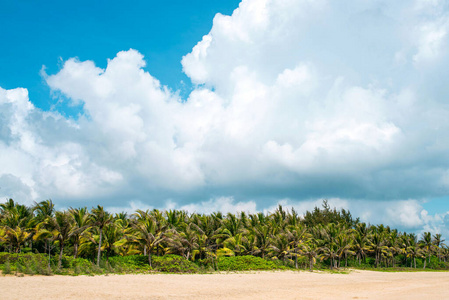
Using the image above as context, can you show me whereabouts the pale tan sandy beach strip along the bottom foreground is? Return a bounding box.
[0,271,449,300]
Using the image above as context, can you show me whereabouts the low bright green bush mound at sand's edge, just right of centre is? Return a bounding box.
[217,255,287,271]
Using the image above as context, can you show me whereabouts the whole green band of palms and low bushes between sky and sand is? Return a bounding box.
[0,199,449,276]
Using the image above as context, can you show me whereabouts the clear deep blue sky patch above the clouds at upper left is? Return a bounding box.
[0,0,239,115]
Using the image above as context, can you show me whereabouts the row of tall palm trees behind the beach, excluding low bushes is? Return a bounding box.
[0,199,449,270]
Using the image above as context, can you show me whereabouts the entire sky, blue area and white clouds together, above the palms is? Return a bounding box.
[0,0,449,238]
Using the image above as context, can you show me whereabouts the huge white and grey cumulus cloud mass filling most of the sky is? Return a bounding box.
[0,0,449,237]
